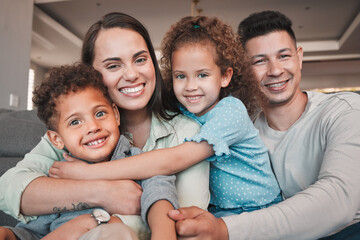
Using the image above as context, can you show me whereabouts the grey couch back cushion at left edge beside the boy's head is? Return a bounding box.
[0,109,46,157]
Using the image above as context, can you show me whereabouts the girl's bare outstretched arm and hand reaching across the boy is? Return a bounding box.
[49,141,214,180]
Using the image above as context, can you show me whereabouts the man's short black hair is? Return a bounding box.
[238,11,296,46]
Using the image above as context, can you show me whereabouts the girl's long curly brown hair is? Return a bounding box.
[161,16,261,116]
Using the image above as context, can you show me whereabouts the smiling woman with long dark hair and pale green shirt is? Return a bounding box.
[0,13,209,240]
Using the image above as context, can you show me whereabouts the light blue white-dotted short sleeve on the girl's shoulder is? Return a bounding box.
[186,98,253,161]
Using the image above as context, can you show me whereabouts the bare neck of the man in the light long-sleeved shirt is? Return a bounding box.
[262,91,307,131]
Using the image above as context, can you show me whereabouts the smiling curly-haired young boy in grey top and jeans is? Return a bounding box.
[0,64,178,239]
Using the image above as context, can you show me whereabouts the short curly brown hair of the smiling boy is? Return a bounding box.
[32,64,112,131]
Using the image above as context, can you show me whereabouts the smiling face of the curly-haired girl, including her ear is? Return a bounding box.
[172,44,232,116]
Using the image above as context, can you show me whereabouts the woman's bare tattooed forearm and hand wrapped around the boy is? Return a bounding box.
[21,177,142,215]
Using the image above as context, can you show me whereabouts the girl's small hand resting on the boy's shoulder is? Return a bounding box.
[49,153,91,179]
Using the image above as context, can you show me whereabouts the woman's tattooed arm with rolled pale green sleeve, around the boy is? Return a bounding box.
[0,137,141,222]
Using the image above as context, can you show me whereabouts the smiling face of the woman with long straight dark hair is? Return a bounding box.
[93,28,156,111]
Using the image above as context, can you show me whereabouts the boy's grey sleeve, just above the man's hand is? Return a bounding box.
[141,175,179,223]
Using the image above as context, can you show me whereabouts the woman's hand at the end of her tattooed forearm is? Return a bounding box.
[100,180,142,215]
